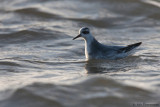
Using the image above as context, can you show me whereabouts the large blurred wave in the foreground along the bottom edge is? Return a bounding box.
[0,77,157,107]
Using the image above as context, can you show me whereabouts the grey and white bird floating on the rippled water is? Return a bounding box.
[73,27,142,60]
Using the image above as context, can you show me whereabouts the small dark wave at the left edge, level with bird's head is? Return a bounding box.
[0,29,66,44]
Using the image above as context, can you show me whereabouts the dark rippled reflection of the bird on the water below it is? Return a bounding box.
[85,56,142,74]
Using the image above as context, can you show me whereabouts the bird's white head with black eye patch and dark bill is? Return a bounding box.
[73,27,92,40]
